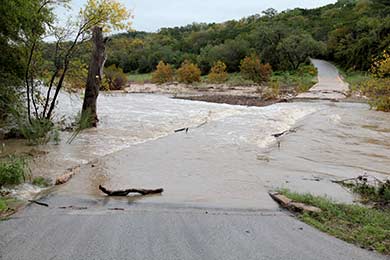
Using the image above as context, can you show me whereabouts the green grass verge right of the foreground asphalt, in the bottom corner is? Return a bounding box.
[279,190,390,255]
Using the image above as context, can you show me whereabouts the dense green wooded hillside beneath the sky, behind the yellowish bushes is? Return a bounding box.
[93,0,390,73]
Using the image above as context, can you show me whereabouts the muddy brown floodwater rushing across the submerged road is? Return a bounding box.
[0,93,390,209]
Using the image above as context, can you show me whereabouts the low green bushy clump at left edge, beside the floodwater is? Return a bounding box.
[0,156,27,187]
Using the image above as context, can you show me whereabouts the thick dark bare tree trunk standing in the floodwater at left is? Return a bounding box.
[82,26,106,127]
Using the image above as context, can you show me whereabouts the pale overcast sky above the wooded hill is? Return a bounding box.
[60,0,336,32]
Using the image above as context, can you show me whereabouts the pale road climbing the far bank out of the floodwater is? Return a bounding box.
[297,59,348,100]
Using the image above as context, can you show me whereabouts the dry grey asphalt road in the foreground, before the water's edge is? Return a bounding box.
[0,196,385,260]
